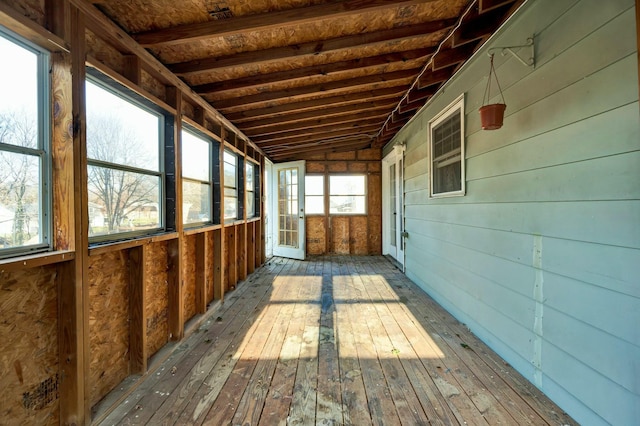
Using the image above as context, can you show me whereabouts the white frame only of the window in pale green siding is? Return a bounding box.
[428,93,466,198]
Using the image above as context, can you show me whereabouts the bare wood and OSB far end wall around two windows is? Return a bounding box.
[305,148,382,255]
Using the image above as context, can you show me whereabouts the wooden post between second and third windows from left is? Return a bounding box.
[165,87,184,340]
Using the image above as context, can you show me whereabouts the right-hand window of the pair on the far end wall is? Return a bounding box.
[329,175,367,214]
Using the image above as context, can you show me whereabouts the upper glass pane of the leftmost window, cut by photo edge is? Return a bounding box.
[0,35,38,148]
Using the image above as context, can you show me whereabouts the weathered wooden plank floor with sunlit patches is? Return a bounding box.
[101,256,575,425]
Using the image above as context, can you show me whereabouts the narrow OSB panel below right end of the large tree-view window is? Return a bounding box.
[145,242,169,356]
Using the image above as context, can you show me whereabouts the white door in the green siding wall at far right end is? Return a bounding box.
[382,146,404,266]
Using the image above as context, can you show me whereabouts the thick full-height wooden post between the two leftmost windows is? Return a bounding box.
[54,8,91,424]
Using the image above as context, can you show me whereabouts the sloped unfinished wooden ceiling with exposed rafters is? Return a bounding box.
[93,0,523,162]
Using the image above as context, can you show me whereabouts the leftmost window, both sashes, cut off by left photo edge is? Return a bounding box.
[0,31,50,258]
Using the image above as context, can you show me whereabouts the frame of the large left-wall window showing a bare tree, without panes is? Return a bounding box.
[85,75,168,246]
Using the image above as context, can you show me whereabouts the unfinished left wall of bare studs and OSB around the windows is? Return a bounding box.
[0,0,265,425]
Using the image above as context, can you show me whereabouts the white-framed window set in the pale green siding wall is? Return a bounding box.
[429,96,465,197]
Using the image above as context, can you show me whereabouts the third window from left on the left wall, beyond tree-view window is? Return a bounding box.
[182,130,213,225]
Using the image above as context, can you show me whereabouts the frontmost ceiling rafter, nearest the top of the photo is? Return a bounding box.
[133,0,444,47]
